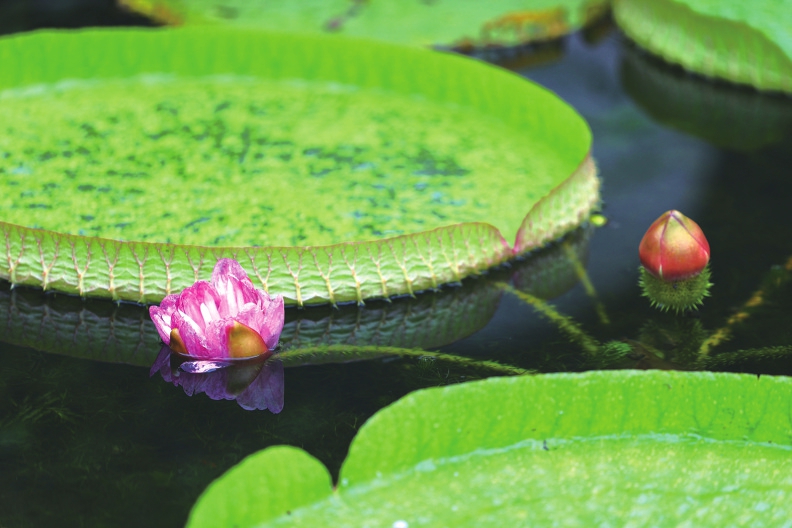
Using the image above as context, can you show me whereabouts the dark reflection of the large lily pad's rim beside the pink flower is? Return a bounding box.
[0,229,591,368]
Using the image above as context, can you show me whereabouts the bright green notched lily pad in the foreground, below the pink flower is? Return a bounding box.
[188,371,792,528]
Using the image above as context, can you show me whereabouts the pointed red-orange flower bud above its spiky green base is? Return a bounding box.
[638,210,710,281]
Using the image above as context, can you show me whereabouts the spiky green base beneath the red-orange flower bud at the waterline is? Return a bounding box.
[639,265,712,313]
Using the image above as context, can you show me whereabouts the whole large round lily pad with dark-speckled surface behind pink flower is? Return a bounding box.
[0,28,599,305]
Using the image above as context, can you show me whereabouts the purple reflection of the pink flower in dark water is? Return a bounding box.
[150,346,284,414]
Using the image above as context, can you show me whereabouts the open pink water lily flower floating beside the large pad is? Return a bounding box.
[149,259,284,359]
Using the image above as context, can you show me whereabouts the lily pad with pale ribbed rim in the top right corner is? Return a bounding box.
[613,0,792,93]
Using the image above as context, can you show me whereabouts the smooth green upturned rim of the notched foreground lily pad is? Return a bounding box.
[187,371,792,528]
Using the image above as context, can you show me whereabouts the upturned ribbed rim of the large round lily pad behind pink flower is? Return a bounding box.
[0,28,599,305]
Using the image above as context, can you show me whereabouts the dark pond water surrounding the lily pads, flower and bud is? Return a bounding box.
[0,2,792,527]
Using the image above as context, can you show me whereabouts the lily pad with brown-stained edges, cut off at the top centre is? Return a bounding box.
[121,0,609,47]
